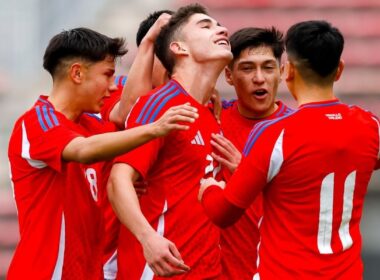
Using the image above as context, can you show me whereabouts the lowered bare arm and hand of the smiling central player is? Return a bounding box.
[107,163,189,276]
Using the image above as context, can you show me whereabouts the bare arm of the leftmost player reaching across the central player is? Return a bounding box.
[62,104,198,163]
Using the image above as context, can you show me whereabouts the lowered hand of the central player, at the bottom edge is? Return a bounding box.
[141,232,190,277]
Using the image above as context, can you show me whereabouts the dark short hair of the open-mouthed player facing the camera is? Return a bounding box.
[230,27,284,67]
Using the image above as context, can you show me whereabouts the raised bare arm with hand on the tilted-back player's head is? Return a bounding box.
[109,13,171,127]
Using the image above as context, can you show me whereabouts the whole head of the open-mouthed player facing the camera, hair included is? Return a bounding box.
[225,27,284,118]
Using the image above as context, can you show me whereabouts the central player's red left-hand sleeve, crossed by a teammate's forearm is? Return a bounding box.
[114,97,164,178]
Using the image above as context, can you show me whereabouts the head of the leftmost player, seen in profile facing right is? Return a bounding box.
[43,28,127,113]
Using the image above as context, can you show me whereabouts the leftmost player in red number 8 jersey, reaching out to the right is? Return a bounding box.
[7,28,196,279]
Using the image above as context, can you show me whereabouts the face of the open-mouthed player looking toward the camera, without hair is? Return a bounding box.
[226,46,281,118]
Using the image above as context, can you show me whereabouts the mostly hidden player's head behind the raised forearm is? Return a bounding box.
[136,10,174,87]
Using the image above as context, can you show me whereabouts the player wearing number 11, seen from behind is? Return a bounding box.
[199,21,380,279]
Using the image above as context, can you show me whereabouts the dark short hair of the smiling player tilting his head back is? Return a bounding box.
[154,4,208,75]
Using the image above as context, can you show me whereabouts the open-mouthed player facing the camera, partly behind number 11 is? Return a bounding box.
[211,27,292,280]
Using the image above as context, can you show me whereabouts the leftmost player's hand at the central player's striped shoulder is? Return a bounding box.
[152,103,199,137]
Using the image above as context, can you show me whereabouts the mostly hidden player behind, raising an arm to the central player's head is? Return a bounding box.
[101,10,173,279]
